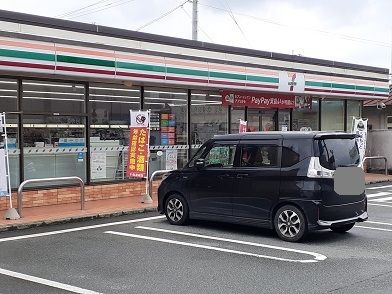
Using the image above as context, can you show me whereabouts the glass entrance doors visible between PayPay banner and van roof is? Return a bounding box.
[248,109,278,132]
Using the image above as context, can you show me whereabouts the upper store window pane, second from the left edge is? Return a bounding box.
[22,80,85,114]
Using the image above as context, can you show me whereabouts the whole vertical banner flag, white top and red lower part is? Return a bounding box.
[127,111,150,178]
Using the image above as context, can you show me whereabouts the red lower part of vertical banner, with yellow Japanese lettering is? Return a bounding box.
[127,127,149,178]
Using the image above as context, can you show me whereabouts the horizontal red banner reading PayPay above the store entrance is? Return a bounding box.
[221,91,295,108]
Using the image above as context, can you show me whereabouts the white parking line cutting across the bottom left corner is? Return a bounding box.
[0,268,99,294]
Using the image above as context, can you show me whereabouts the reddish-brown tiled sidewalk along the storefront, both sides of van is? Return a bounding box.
[0,174,392,231]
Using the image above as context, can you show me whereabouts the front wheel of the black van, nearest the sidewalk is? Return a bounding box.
[165,194,189,225]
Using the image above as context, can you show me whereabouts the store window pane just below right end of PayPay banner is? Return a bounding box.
[292,98,319,131]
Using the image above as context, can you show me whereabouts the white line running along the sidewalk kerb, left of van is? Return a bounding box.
[0,215,165,243]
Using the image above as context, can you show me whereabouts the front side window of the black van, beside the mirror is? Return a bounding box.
[204,144,237,167]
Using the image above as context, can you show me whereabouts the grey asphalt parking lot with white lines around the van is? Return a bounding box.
[0,184,392,293]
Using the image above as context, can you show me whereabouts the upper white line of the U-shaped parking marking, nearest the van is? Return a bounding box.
[136,226,327,261]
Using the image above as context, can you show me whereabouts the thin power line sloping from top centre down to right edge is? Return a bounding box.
[200,3,391,48]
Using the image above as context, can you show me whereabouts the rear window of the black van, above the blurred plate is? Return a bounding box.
[316,138,360,170]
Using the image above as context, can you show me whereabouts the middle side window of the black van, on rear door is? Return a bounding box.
[240,145,279,167]
